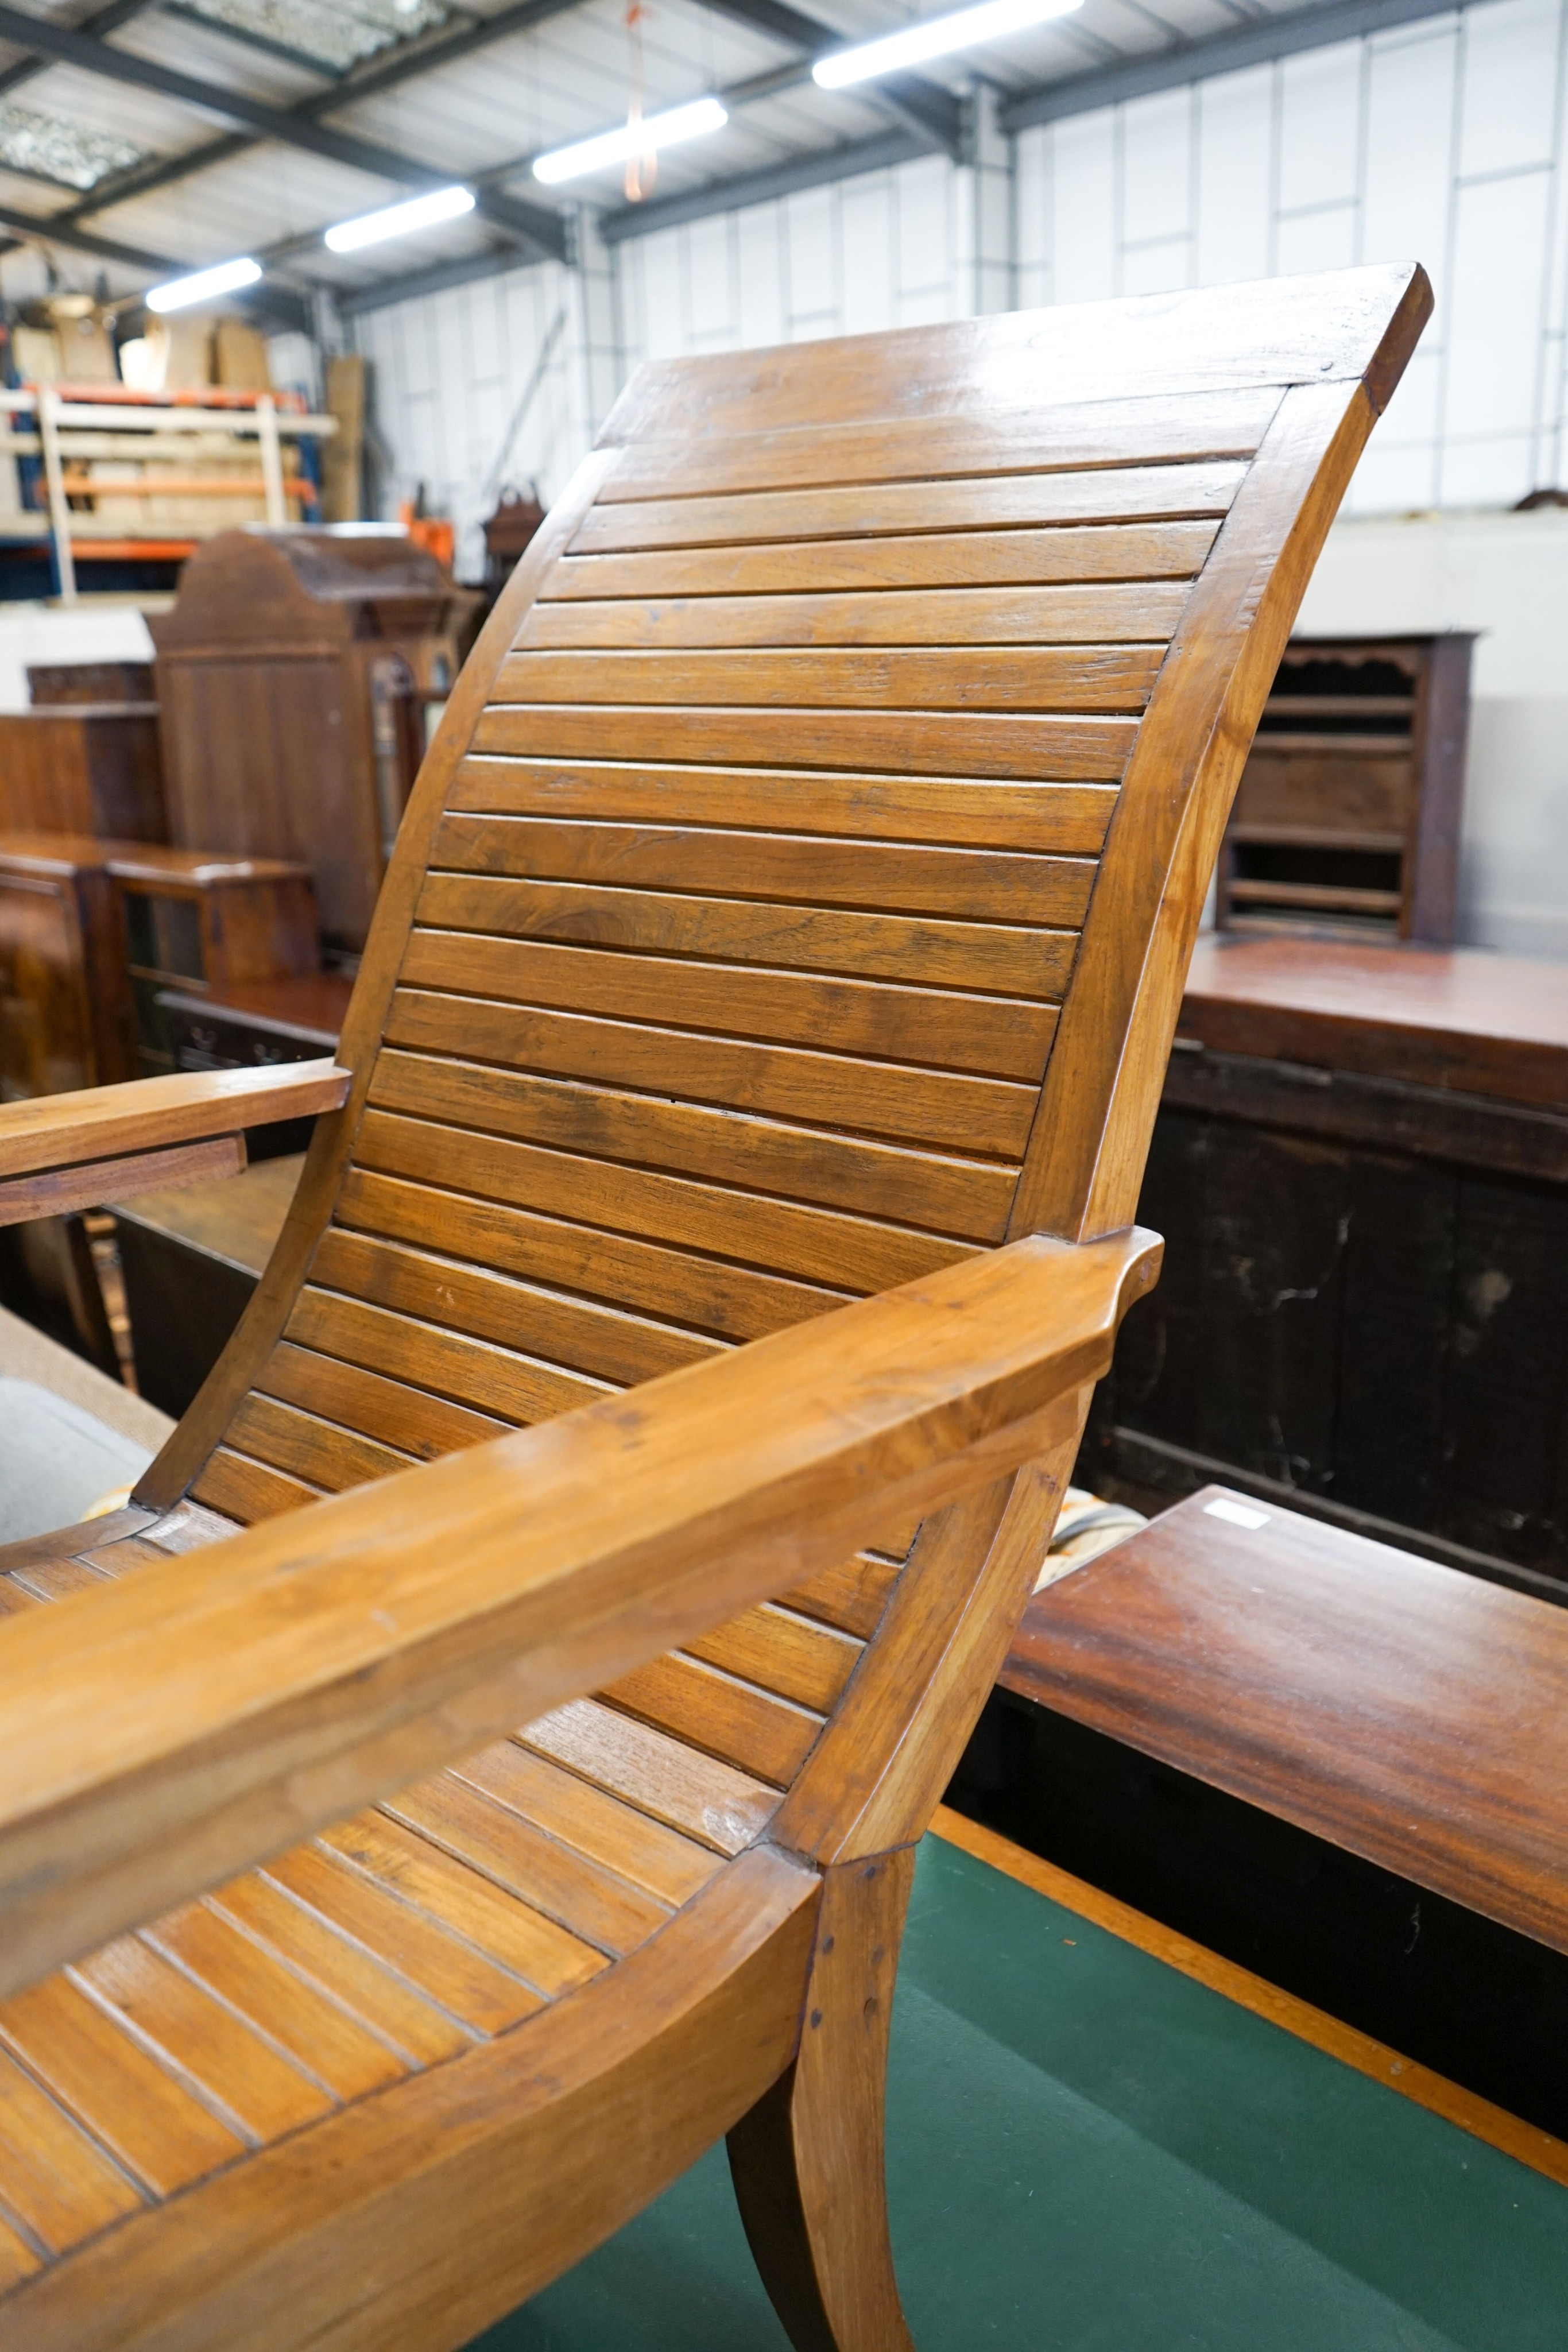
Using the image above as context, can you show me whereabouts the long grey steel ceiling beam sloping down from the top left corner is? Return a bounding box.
[0,5,567,261]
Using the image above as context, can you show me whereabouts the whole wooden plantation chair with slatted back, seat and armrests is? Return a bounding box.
[0,268,1429,2352]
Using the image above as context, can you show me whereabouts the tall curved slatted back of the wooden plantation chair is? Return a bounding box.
[141,268,1427,1835]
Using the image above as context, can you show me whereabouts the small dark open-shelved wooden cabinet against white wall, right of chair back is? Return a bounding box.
[1215,633,1474,946]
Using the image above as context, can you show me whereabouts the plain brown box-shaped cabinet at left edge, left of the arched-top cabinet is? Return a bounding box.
[0,701,167,842]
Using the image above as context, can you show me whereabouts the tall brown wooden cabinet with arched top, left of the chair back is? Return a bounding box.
[148,529,470,950]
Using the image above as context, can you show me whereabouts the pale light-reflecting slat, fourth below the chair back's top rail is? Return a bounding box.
[517,581,1187,652]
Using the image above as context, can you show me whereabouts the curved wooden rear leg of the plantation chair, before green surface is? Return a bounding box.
[729,1846,915,2352]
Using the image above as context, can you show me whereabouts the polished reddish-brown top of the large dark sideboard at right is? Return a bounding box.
[1178,931,1568,1105]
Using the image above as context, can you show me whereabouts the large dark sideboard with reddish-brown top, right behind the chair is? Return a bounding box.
[1079,934,1568,1599]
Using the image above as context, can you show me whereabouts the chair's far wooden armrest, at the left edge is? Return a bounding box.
[0,1058,353,1225]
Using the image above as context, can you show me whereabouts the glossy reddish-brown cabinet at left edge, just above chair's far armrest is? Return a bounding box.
[0,835,136,1101]
